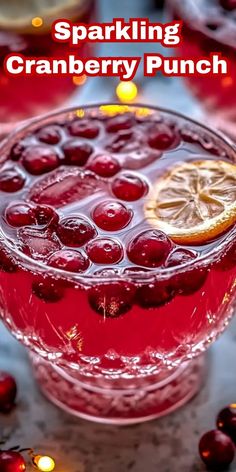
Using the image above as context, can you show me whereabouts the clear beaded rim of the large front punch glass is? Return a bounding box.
[0,102,236,283]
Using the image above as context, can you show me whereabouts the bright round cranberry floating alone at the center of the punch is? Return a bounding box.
[92,201,133,231]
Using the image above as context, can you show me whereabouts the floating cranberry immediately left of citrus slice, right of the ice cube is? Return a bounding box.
[112,174,147,202]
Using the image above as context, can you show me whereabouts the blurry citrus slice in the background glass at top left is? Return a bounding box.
[0,0,87,33]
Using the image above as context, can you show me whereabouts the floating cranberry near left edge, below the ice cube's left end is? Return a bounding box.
[5,203,36,227]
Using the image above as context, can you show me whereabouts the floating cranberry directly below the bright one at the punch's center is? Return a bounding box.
[86,238,123,264]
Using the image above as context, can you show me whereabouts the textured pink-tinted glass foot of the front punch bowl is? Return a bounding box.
[31,354,205,425]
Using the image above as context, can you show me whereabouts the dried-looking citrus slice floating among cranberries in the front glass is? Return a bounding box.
[144,160,236,244]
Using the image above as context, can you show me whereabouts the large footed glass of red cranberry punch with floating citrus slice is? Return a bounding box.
[0,105,236,424]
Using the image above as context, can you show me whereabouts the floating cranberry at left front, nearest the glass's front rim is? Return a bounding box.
[48,249,89,272]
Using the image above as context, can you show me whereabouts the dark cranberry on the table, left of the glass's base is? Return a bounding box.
[0,372,17,412]
